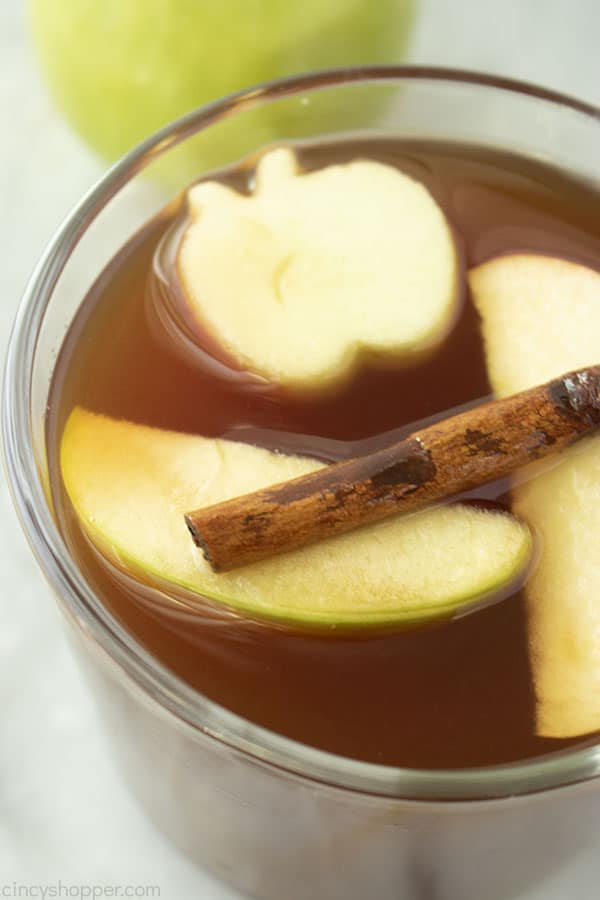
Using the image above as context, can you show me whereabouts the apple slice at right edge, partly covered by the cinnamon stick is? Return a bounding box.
[469,255,600,737]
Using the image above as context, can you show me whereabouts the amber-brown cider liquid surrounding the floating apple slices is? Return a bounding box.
[47,140,600,768]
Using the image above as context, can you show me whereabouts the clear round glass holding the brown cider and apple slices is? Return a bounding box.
[3,67,600,900]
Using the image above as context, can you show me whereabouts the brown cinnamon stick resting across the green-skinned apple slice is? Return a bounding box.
[185,366,600,572]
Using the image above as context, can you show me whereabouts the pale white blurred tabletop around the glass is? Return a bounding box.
[0,0,600,900]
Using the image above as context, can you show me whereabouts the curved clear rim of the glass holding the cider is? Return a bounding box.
[7,66,600,802]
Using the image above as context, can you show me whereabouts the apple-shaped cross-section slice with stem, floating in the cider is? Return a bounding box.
[177,148,458,390]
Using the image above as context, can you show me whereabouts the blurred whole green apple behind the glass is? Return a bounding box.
[29,0,415,171]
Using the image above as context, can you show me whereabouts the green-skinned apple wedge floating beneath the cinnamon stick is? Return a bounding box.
[60,408,532,626]
